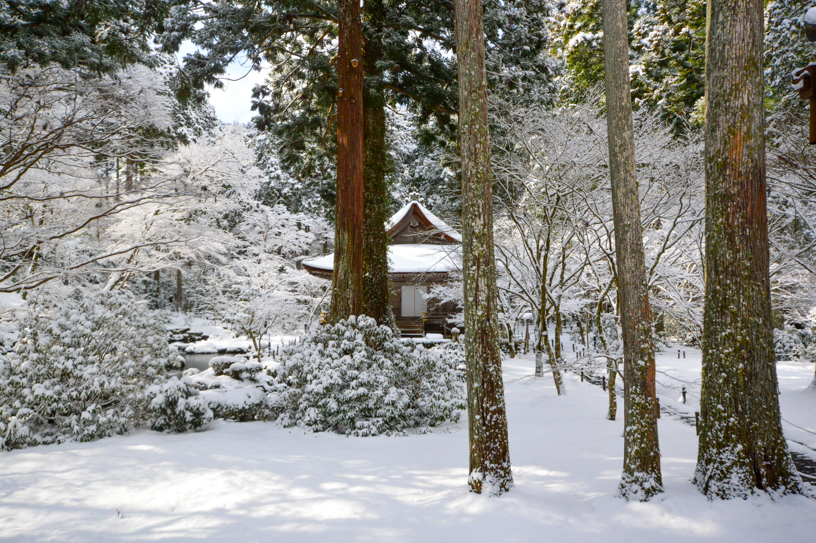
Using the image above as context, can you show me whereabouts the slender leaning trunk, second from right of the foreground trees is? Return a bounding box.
[603,0,663,500]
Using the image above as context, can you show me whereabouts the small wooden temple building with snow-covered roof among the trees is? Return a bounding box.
[303,202,462,337]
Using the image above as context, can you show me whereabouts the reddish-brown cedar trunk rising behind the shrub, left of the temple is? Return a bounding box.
[329,0,364,322]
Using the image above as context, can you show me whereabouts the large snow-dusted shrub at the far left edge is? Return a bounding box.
[0,291,176,449]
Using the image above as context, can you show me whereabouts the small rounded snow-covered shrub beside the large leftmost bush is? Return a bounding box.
[147,377,213,433]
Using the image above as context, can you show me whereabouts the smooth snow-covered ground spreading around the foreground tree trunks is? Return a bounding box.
[0,340,816,543]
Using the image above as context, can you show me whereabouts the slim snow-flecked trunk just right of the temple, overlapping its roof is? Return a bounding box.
[455,0,513,495]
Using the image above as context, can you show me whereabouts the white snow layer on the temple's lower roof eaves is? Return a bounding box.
[303,243,461,273]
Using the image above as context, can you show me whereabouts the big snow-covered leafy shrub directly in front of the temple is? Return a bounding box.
[278,316,465,436]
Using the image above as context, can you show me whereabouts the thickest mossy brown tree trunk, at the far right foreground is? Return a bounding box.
[694,0,801,499]
